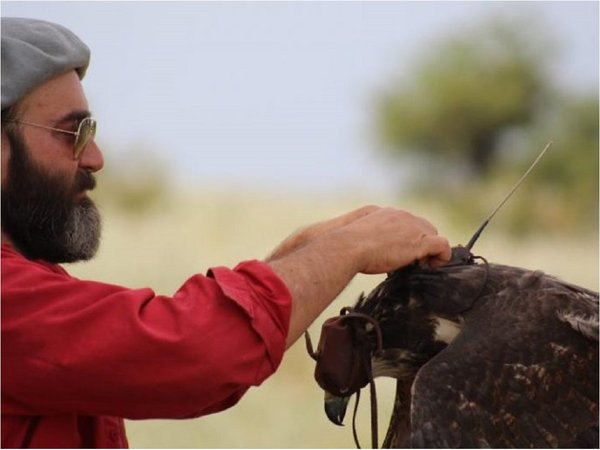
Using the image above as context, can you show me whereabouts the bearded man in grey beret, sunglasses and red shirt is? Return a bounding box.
[2,18,450,448]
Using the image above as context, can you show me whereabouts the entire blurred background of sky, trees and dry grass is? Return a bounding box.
[1,1,599,448]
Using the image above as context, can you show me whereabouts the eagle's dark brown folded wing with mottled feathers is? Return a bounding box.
[411,266,598,448]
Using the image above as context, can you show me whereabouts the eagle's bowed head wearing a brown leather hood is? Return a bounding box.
[315,246,485,425]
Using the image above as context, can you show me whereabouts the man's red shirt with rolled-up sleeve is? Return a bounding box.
[1,245,291,448]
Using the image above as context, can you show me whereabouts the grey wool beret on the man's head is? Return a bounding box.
[0,17,90,110]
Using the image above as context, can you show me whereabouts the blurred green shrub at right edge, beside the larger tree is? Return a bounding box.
[509,94,599,231]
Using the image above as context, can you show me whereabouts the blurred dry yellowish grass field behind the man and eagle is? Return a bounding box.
[68,190,598,448]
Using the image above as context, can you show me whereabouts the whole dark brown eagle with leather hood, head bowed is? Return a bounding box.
[307,246,599,448]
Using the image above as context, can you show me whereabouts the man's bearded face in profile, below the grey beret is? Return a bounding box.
[2,71,103,262]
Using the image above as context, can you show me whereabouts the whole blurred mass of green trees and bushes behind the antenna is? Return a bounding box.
[375,14,598,234]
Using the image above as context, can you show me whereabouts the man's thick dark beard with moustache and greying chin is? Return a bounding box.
[2,130,101,263]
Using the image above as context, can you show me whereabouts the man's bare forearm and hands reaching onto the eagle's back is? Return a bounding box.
[267,206,451,347]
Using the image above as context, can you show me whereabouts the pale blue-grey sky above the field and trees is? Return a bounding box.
[1,1,599,192]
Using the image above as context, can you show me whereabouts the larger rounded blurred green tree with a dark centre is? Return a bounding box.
[377,20,549,176]
